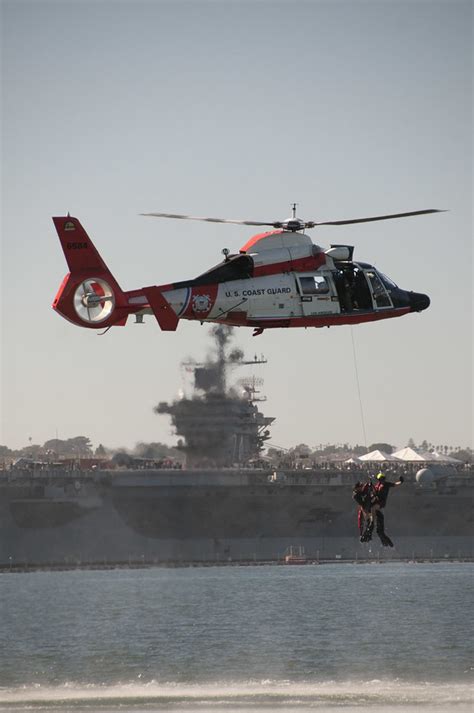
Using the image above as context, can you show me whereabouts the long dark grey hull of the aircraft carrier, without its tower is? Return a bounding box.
[0,471,473,566]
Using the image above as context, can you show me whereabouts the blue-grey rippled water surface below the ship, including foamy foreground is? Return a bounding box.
[0,563,474,713]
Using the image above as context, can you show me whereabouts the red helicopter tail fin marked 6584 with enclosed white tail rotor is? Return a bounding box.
[53,215,130,329]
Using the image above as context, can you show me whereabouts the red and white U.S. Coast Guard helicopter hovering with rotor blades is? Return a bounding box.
[53,204,442,335]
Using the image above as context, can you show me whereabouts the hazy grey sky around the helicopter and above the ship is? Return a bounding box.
[0,0,473,447]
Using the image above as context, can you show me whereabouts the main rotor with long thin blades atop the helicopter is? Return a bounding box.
[140,204,445,232]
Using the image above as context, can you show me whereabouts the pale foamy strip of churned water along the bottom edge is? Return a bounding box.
[0,679,473,713]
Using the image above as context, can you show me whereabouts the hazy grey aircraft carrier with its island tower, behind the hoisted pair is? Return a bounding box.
[0,326,474,569]
